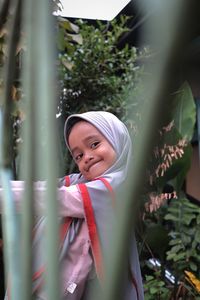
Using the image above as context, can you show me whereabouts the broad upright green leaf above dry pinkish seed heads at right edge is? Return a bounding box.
[173,82,196,141]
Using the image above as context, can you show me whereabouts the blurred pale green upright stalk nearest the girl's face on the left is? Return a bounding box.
[27,0,60,300]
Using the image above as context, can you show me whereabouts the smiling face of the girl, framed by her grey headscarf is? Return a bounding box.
[68,121,116,180]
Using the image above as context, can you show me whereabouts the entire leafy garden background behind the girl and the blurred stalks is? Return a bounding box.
[0,1,200,300]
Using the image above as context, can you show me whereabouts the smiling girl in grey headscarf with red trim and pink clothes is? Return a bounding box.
[3,111,144,300]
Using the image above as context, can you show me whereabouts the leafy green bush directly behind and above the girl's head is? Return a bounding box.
[55,17,145,173]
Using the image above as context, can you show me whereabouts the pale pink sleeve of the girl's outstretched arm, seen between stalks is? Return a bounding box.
[0,181,84,218]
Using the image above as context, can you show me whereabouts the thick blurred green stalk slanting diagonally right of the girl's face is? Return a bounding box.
[101,1,190,300]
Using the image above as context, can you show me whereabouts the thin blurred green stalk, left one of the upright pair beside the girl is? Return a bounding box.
[19,0,37,300]
